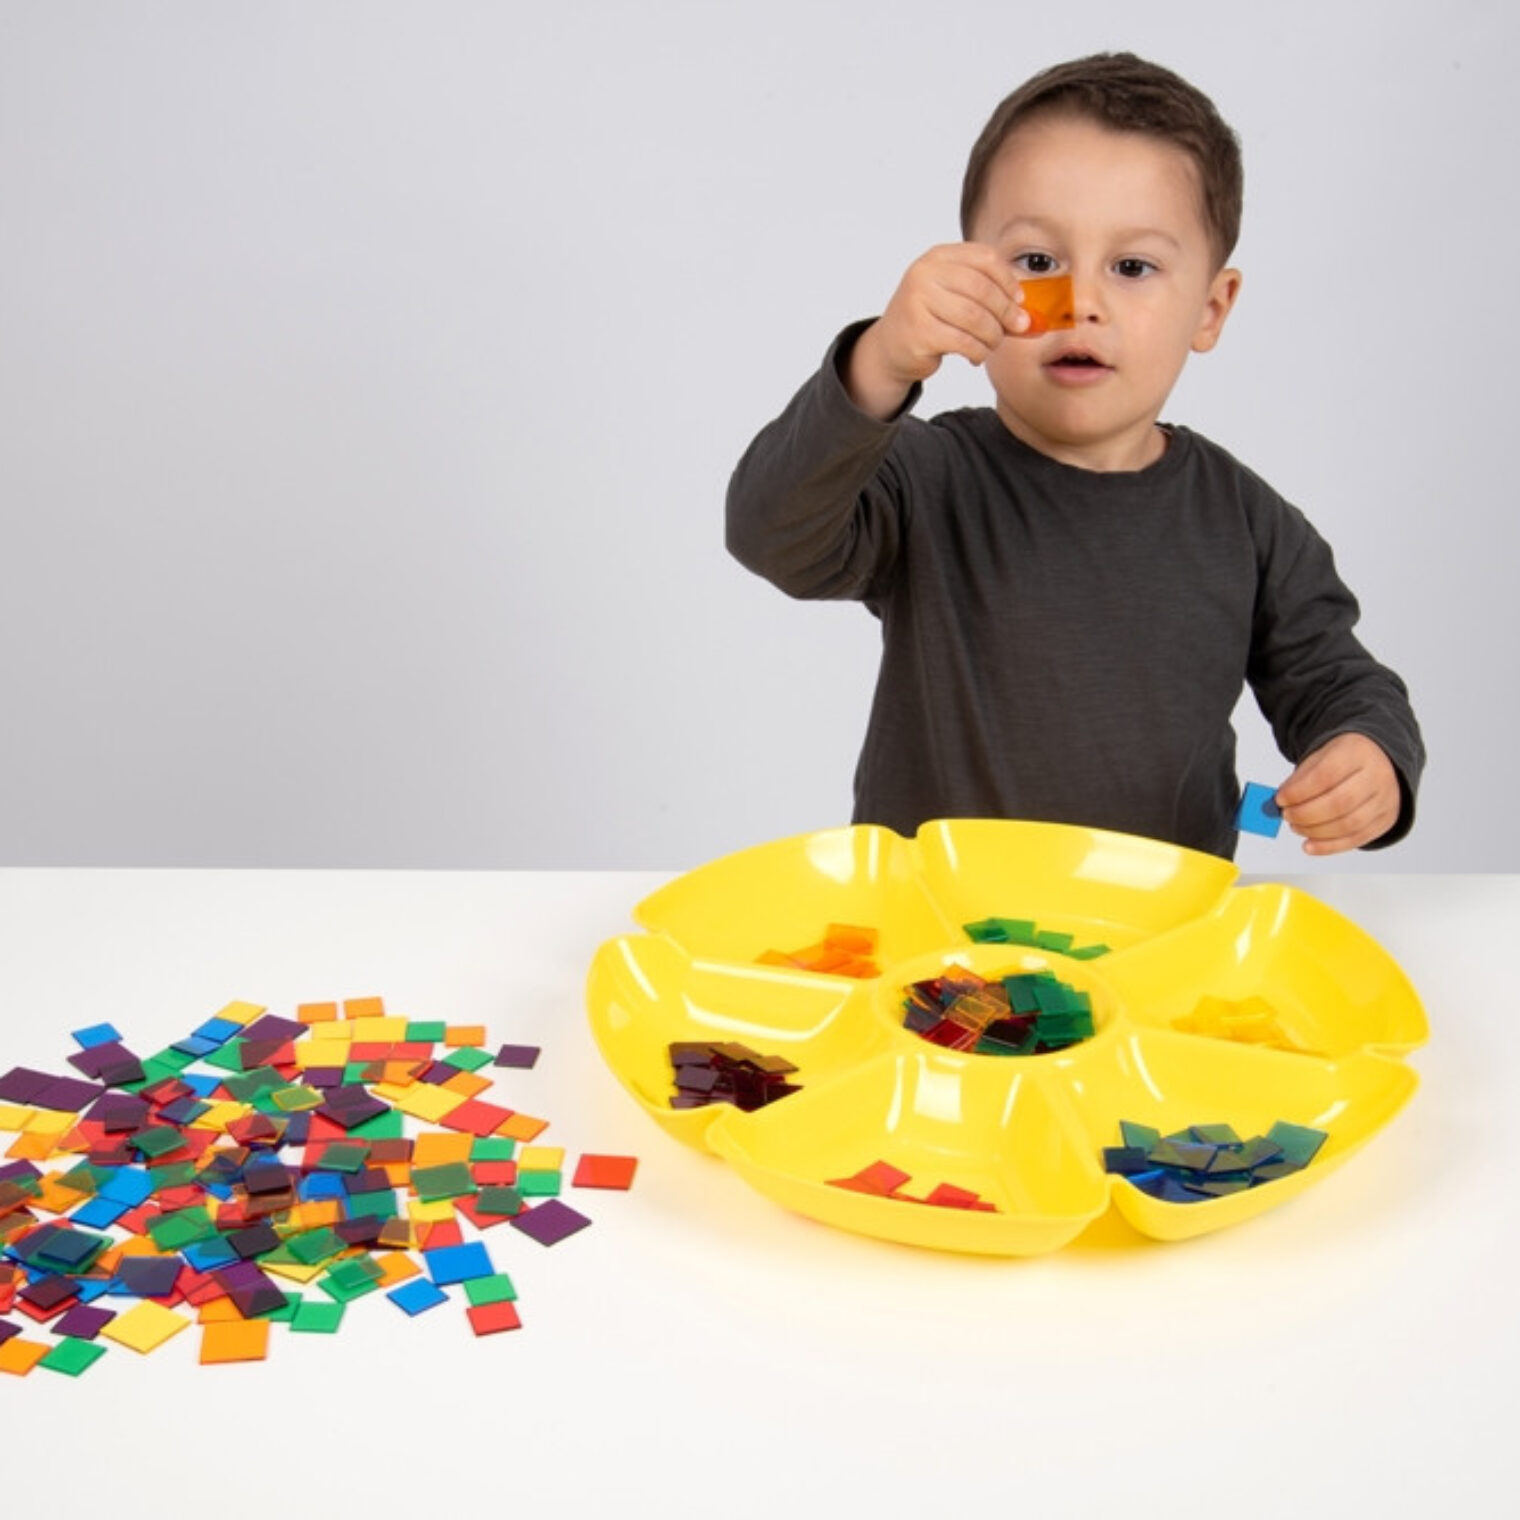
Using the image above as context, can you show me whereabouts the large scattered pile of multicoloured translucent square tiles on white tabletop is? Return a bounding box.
[0,999,637,1376]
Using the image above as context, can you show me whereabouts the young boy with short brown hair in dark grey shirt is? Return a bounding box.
[728,53,1424,857]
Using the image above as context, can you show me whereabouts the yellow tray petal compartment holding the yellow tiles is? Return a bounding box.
[1104,885,1429,1055]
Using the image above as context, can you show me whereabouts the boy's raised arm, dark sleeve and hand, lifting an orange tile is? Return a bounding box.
[727,243,1028,597]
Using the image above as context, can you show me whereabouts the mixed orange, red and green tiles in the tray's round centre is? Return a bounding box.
[903,967,1093,1055]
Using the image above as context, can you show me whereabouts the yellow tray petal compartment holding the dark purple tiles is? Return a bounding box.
[587,935,889,1148]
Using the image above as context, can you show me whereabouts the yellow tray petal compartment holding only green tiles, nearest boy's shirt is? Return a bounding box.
[914,818,1239,950]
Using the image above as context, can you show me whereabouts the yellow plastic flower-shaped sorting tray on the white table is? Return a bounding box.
[587,819,1427,1256]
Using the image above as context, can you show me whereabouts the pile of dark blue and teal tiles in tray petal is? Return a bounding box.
[1104,1119,1328,1204]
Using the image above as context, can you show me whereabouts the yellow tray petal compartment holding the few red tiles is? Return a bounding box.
[708,1046,1108,1256]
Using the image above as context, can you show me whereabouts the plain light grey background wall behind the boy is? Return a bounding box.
[0,0,1520,871]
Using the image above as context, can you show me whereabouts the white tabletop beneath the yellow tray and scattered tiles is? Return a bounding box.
[0,869,1520,1520]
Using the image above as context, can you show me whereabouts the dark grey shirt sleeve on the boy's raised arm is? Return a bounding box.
[727,322,921,600]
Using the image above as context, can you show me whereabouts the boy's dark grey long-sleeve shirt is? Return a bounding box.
[728,324,1424,857]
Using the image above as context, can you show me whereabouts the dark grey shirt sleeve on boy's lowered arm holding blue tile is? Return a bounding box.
[1246,483,1426,848]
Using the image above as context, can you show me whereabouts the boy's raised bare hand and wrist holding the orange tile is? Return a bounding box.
[845,243,1029,420]
